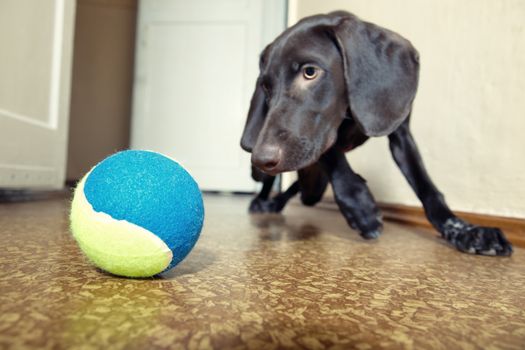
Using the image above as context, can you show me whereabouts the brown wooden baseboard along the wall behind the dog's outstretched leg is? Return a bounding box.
[379,203,525,248]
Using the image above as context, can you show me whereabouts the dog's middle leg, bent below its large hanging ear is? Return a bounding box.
[321,148,383,239]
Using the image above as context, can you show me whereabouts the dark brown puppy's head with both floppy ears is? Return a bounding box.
[241,11,418,174]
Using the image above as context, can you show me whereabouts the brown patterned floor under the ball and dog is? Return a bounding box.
[0,196,525,349]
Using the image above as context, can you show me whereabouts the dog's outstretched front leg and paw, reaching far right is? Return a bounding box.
[389,120,512,256]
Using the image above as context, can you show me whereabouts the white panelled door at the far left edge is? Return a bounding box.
[0,0,75,188]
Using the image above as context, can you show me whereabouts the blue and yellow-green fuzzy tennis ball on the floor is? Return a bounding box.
[70,150,204,277]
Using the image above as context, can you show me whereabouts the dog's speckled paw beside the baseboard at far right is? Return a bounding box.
[441,218,512,256]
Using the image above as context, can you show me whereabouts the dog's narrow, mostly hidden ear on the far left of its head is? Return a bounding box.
[241,79,268,152]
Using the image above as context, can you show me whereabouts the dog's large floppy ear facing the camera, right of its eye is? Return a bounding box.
[332,12,419,136]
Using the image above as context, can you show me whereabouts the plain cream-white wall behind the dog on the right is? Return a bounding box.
[289,0,525,218]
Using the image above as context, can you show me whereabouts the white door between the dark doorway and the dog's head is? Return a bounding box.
[131,0,286,191]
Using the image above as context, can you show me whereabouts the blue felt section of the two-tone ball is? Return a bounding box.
[84,150,204,268]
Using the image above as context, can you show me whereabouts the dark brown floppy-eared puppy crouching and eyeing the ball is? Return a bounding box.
[241,11,512,255]
